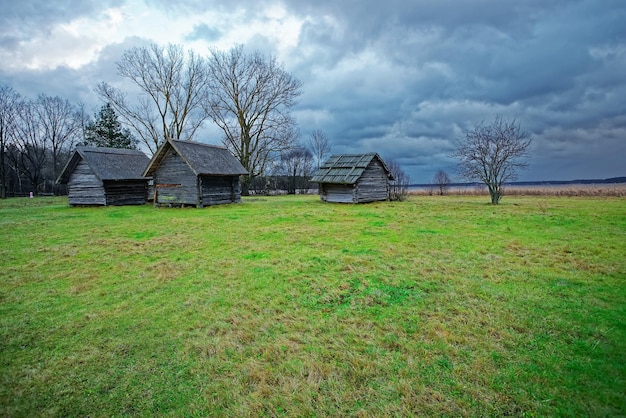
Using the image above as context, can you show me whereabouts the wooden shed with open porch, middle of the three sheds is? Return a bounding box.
[143,139,248,208]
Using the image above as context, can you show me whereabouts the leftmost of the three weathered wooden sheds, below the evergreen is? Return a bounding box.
[57,146,150,206]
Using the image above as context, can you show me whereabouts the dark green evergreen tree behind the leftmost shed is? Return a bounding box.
[85,103,138,149]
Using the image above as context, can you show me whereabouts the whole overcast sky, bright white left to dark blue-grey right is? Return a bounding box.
[0,0,626,183]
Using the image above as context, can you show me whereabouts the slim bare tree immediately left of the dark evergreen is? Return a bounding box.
[35,94,81,183]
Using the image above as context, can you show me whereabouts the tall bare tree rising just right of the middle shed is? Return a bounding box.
[205,45,302,195]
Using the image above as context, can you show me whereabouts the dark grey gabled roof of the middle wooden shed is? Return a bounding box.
[144,139,248,176]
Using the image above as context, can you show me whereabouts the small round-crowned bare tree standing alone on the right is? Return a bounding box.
[452,116,532,205]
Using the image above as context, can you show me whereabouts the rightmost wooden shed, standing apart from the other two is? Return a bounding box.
[311,152,393,203]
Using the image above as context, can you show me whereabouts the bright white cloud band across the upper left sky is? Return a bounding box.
[0,2,303,71]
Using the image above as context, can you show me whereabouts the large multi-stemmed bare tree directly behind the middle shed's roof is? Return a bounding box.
[96,44,209,153]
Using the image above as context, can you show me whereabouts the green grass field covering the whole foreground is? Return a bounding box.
[0,196,626,417]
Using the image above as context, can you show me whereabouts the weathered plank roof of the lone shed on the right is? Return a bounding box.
[311,152,393,184]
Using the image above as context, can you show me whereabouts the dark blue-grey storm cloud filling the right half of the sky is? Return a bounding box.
[282,0,626,181]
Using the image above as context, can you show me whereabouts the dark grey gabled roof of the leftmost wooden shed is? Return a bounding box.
[57,146,150,183]
